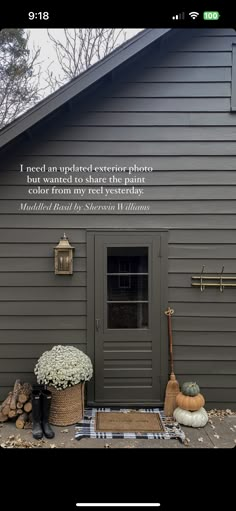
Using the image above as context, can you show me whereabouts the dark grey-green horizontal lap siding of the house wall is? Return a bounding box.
[0,29,236,409]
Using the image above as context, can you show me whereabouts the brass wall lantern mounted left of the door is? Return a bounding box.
[54,233,74,275]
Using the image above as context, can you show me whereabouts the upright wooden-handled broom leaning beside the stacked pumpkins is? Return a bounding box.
[164,307,180,417]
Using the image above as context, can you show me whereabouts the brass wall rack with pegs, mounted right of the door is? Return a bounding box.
[192,266,236,293]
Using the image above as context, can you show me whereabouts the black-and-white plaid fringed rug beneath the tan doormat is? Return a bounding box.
[75,408,185,442]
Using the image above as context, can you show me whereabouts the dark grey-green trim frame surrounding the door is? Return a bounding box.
[86,228,168,406]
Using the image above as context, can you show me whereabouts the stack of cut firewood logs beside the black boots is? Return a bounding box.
[0,380,32,429]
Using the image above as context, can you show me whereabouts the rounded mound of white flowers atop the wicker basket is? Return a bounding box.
[34,345,93,390]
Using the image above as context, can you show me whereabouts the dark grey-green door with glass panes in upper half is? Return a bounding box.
[94,232,166,405]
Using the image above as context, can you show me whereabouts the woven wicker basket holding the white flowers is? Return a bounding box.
[48,383,84,426]
